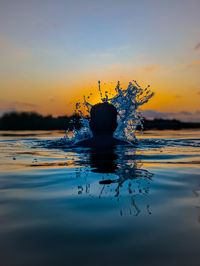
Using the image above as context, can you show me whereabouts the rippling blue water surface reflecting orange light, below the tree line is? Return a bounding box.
[0,130,200,266]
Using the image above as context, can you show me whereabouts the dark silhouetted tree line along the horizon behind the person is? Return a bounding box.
[0,112,200,130]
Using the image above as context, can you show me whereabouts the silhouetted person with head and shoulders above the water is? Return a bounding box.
[76,103,128,150]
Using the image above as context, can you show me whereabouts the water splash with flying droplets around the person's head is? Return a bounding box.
[65,80,154,142]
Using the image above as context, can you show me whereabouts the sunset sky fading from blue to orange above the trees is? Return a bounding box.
[0,0,200,121]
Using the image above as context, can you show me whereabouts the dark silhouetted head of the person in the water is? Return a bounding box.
[90,103,117,136]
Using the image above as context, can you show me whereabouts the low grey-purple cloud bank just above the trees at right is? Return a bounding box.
[142,110,200,122]
